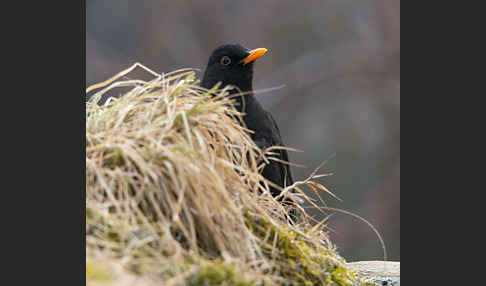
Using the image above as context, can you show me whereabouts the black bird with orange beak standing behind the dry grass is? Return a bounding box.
[201,44,296,220]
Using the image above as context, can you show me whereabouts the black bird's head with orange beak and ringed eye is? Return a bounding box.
[201,44,267,91]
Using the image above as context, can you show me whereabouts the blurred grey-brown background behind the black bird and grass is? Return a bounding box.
[86,0,400,261]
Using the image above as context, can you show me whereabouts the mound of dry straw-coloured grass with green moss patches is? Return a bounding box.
[86,63,366,285]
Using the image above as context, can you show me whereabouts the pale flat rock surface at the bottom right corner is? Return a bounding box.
[347,261,400,286]
